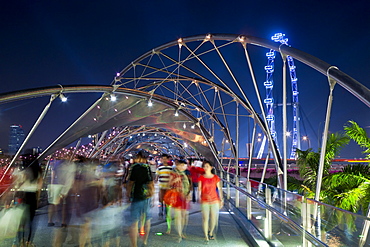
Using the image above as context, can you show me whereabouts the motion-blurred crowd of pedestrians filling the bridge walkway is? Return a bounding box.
[0,150,223,247]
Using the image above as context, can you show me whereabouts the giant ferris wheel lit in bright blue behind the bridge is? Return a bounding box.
[257,33,300,159]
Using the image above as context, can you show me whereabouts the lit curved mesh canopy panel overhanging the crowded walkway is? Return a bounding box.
[42,91,212,157]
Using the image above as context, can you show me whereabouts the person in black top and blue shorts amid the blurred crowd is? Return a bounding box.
[126,150,154,247]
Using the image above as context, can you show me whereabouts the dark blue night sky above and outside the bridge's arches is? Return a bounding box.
[0,0,370,157]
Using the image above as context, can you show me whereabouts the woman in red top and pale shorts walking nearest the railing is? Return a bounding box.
[198,161,223,243]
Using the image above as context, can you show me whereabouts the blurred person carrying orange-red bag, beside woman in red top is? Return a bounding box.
[168,160,191,243]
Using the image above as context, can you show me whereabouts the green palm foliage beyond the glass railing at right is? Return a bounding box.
[297,121,370,213]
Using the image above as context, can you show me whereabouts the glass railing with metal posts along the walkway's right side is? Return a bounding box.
[219,172,370,247]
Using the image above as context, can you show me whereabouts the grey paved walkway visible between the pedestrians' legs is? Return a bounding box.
[0,186,248,247]
